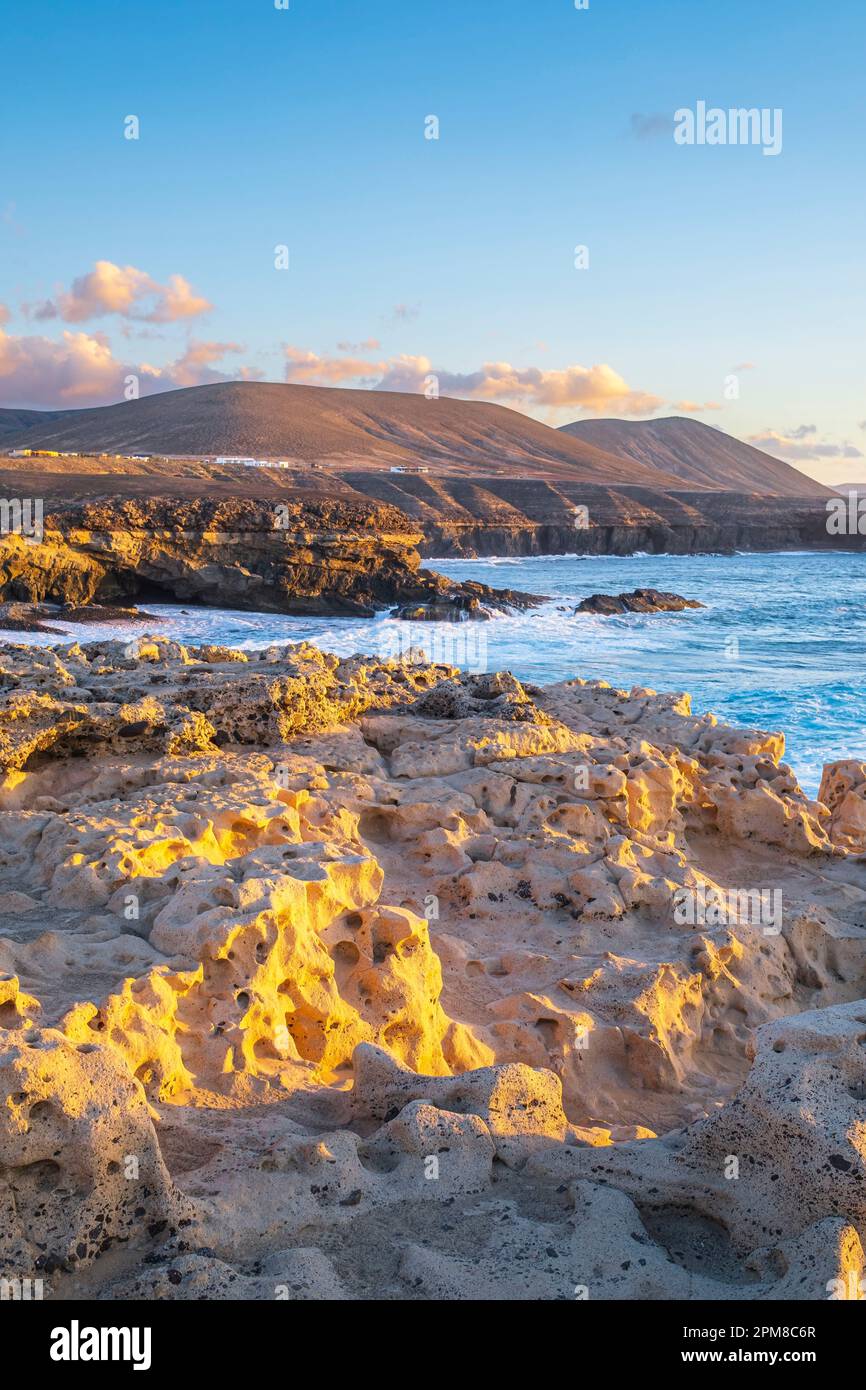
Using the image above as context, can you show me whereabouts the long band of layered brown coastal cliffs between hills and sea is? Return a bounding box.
[0,459,866,583]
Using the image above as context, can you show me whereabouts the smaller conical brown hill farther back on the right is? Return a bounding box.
[559,416,831,496]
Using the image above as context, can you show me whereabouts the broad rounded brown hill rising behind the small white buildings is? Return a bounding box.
[3,382,686,488]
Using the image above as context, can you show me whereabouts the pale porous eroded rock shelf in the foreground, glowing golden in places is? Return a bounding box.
[0,637,866,1301]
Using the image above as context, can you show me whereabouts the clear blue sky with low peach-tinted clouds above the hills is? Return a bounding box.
[0,0,866,481]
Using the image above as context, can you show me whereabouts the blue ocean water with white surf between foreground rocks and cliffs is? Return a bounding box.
[0,552,866,792]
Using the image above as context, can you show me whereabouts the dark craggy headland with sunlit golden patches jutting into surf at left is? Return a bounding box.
[0,498,536,616]
